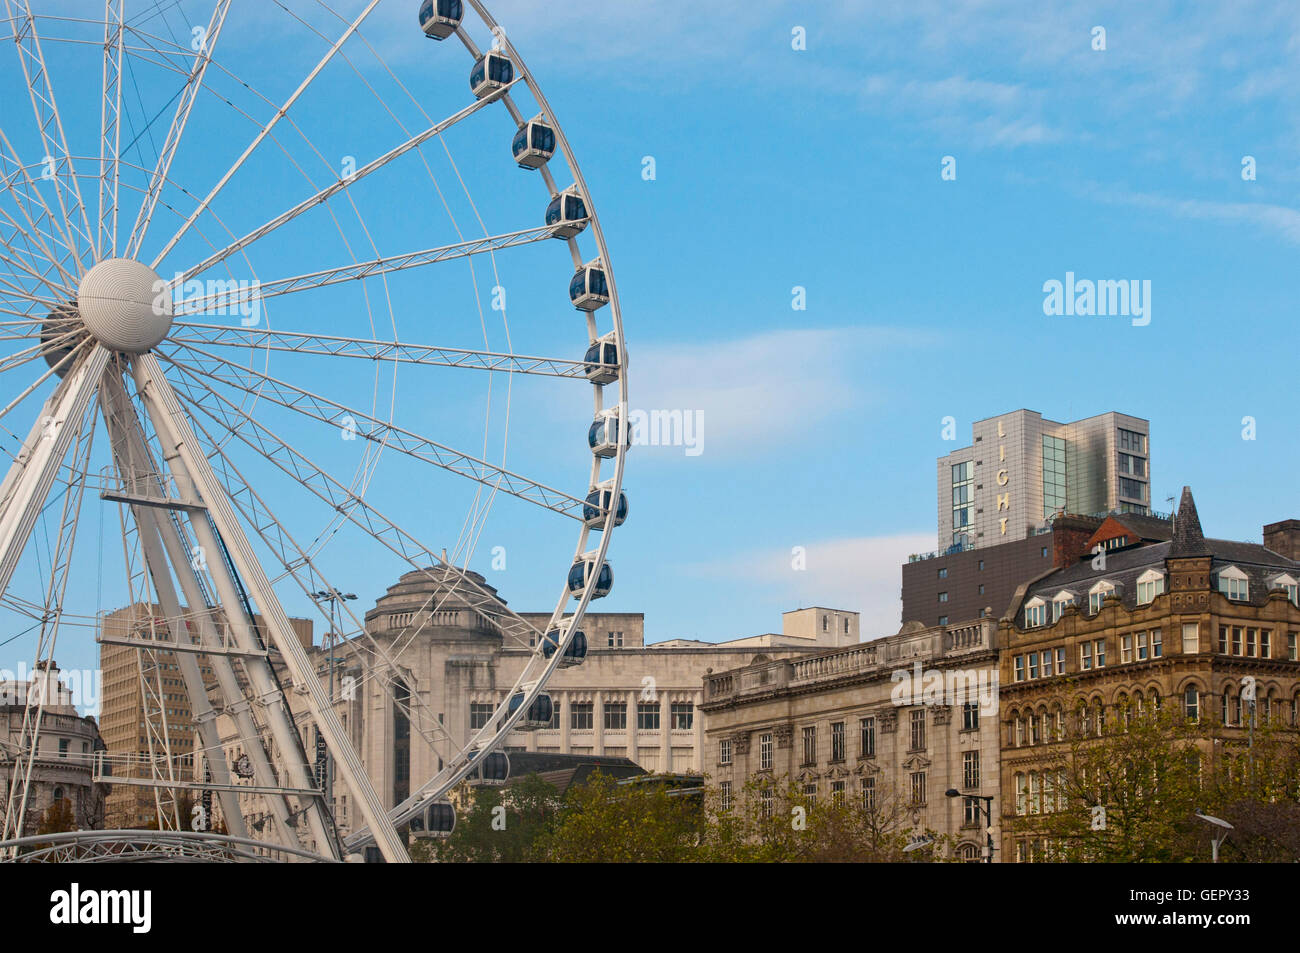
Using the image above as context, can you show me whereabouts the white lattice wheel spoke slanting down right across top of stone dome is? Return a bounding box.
[163,364,542,645]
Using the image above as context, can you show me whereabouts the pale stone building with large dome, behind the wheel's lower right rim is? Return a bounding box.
[208,569,858,836]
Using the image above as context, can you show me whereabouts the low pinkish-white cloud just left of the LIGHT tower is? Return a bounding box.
[692,533,935,640]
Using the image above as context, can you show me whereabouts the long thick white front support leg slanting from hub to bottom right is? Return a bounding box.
[131,354,411,863]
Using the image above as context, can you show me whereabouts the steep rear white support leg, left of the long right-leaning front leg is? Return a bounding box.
[100,371,252,846]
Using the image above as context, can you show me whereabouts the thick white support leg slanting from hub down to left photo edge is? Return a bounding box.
[0,345,109,593]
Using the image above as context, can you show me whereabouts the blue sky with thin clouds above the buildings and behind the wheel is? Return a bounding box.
[0,0,1300,696]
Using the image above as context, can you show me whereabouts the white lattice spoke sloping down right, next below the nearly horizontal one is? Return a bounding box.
[166,345,584,521]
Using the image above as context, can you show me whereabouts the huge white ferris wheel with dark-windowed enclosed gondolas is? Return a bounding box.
[0,0,631,862]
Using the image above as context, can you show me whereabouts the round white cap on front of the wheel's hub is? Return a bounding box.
[77,259,172,354]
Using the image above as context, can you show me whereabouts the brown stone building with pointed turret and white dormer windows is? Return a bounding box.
[998,488,1300,859]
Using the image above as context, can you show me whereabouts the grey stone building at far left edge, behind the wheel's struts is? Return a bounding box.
[0,663,108,835]
